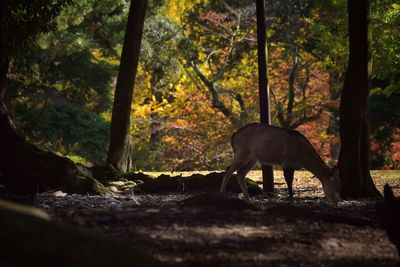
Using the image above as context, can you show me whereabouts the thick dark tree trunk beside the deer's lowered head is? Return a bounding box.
[339,0,379,198]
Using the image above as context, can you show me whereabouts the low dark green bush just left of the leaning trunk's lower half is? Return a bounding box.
[14,103,109,163]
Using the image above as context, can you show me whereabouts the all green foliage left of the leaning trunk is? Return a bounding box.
[7,0,128,163]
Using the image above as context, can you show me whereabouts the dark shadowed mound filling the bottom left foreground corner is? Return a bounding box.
[0,200,165,267]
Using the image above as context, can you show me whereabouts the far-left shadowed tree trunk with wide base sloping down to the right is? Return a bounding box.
[0,0,106,197]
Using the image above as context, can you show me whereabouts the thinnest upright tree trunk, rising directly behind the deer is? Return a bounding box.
[256,0,274,192]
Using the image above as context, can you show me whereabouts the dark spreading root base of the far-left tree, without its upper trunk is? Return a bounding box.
[0,128,108,195]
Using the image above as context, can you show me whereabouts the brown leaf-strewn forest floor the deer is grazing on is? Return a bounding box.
[21,171,400,266]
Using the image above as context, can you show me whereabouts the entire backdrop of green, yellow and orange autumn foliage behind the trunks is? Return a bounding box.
[6,0,400,171]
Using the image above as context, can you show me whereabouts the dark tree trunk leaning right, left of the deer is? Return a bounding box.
[107,0,146,171]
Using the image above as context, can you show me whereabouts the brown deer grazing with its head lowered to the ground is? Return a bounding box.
[219,123,342,206]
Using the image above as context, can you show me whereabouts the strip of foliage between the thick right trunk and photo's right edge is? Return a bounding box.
[369,0,400,169]
